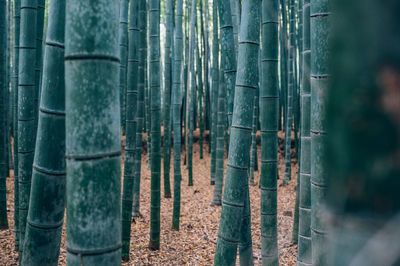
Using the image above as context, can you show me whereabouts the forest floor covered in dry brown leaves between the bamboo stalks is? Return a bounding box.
[0,132,297,265]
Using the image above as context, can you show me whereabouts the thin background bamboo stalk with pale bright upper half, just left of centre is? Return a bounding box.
[187,0,196,186]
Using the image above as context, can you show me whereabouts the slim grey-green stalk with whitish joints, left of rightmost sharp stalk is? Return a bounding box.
[297,0,312,265]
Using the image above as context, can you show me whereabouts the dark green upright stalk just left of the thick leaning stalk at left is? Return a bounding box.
[18,0,37,251]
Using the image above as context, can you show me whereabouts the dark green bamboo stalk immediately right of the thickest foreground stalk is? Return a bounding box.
[120,1,140,261]
